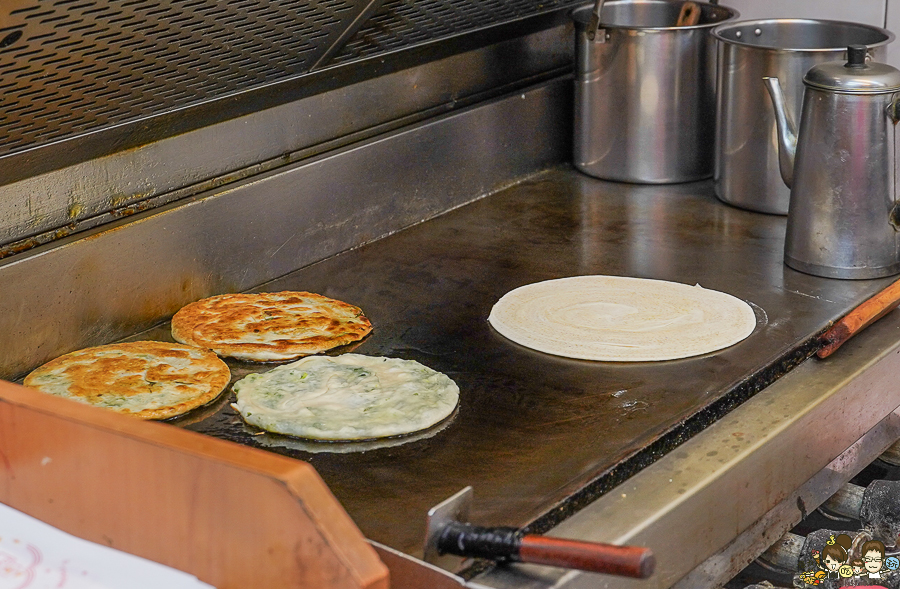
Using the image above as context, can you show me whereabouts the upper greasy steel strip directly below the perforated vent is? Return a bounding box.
[0,24,573,249]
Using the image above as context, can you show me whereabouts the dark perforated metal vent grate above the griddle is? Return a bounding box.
[0,0,583,158]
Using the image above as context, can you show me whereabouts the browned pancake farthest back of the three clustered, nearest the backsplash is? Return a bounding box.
[172,291,372,362]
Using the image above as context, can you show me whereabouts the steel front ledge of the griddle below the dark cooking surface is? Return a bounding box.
[474,313,900,589]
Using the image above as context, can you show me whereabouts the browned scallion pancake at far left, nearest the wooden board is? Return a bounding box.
[24,342,231,419]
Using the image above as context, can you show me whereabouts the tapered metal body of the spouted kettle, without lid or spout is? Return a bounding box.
[784,87,900,279]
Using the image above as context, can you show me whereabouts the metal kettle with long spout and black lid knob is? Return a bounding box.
[764,45,900,279]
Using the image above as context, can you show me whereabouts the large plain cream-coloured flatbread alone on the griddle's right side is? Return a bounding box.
[488,276,756,362]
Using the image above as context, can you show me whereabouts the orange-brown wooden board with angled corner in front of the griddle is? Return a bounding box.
[0,381,389,589]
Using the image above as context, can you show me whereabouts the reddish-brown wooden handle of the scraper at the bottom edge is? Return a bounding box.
[519,535,656,579]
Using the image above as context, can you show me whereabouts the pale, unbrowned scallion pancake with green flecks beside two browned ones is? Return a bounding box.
[234,354,459,441]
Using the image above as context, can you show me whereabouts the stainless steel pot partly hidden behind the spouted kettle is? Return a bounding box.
[713,19,894,215]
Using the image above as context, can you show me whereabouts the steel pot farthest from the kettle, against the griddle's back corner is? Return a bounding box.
[572,0,737,184]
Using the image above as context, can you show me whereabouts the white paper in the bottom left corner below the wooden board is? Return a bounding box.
[0,503,212,589]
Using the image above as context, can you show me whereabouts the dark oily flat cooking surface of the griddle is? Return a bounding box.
[144,169,890,555]
